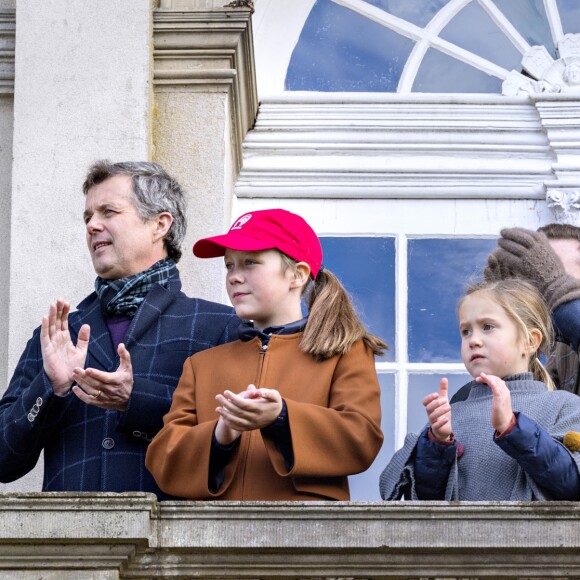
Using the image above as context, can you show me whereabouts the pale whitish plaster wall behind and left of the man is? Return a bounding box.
[1,0,152,490]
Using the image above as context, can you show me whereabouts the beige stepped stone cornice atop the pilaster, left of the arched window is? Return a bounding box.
[153,0,258,169]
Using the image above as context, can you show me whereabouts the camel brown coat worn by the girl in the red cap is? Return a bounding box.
[146,333,383,500]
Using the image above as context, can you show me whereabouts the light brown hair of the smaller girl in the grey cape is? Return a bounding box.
[459,278,555,391]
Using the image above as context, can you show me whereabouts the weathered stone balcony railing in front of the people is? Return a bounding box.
[0,493,580,580]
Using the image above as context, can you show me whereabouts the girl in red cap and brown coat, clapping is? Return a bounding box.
[146,209,386,500]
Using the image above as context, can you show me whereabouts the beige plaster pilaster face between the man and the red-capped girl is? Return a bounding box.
[154,90,232,304]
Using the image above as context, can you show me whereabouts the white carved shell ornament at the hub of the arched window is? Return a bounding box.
[502,34,580,96]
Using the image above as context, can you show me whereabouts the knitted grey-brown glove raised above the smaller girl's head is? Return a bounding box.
[490,228,580,310]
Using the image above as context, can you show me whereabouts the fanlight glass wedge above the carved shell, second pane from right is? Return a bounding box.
[494,0,556,57]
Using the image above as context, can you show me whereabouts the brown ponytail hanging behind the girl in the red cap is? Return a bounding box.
[300,269,388,360]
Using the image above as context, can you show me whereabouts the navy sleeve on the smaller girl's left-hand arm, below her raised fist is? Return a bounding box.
[415,427,458,500]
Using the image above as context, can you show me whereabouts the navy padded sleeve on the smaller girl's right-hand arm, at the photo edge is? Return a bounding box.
[494,413,580,500]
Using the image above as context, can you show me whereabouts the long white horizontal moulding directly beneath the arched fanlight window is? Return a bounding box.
[236,95,553,199]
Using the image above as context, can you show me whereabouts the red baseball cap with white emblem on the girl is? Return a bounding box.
[193,209,322,278]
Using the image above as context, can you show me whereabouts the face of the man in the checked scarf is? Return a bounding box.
[84,175,167,280]
